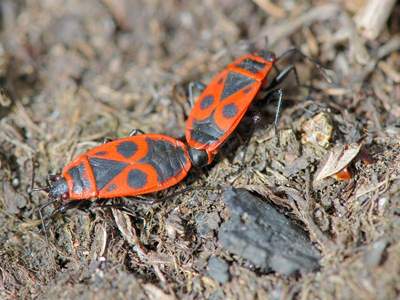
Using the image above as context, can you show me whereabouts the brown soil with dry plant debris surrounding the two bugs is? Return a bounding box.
[0,0,400,299]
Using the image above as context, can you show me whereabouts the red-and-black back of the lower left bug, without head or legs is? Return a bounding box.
[62,134,191,200]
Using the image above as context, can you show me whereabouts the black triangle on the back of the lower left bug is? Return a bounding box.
[89,157,128,190]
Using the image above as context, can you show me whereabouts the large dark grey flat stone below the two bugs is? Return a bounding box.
[219,189,320,275]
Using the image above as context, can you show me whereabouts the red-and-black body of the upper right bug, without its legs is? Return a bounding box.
[185,51,276,163]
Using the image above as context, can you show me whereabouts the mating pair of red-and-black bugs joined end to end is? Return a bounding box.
[42,49,318,210]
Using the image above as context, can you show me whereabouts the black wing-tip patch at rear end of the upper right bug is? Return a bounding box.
[190,111,224,145]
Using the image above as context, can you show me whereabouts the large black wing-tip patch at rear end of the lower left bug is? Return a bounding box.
[140,138,187,183]
